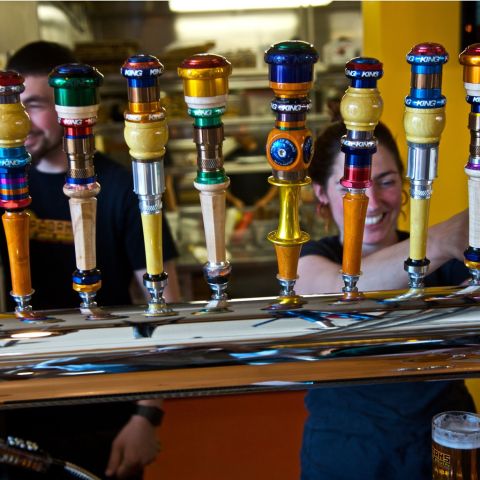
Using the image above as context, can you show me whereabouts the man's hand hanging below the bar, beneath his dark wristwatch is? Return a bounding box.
[105,415,160,479]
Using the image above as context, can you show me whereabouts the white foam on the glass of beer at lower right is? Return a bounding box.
[432,412,480,450]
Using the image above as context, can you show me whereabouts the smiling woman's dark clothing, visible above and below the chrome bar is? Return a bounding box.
[301,232,475,480]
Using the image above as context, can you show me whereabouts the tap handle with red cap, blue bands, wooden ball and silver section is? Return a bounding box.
[403,43,448,290]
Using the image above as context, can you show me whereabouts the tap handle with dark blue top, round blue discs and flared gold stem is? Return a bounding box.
[265,41,318,310]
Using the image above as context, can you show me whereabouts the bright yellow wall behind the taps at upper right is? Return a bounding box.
[362,1,470,228]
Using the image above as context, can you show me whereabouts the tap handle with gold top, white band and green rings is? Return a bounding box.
[178,53,232,312]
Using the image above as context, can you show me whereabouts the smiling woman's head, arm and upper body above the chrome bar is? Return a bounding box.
[296,119,468,294]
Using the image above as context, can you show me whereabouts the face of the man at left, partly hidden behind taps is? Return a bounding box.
[20,75,63,164]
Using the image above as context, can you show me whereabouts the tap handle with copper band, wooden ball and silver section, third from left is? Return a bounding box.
[121,55,174,316]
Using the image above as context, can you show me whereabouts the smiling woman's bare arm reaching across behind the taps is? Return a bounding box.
[295,210,468,294]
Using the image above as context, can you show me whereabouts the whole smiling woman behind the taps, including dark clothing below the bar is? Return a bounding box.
[296,123,474,480]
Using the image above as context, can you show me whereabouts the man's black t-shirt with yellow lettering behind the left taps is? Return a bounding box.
[3,153,177,310]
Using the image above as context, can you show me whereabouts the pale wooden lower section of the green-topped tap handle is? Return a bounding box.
[69,197,97,270]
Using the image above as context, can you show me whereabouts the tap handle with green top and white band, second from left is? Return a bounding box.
[49,63,103,315]
